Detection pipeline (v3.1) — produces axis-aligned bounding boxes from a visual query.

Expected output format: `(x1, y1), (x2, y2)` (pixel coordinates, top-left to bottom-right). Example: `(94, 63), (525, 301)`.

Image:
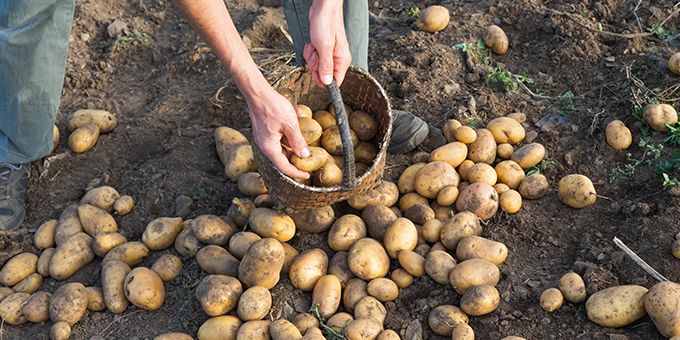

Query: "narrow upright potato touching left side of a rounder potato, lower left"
(102, 260), (131, 314)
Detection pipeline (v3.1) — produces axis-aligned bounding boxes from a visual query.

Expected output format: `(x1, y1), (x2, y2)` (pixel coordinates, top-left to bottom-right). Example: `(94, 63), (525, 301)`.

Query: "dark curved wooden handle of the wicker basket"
(328, 79), (357, 190)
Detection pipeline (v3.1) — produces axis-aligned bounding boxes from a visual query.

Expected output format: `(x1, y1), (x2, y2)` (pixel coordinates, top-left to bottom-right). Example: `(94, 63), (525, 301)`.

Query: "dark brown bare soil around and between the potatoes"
(0, 0), (680, 339)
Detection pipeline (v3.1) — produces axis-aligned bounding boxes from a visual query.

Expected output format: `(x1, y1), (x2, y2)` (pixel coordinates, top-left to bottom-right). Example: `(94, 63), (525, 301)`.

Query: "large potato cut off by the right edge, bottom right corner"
(644, 281), (680, 337)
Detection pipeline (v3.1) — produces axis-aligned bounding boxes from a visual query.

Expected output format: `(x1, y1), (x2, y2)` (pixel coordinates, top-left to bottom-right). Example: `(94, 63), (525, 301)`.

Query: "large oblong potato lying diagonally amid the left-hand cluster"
(49, 232), (94, 283)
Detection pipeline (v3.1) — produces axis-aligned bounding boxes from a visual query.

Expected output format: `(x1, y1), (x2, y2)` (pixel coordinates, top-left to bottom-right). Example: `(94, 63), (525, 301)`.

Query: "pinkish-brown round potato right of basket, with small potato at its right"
(456, 182), (498, 221)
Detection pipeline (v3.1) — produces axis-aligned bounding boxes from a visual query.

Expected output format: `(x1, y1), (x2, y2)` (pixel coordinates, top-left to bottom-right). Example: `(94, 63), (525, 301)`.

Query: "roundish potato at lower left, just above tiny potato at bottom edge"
(49, 282), (87, 326)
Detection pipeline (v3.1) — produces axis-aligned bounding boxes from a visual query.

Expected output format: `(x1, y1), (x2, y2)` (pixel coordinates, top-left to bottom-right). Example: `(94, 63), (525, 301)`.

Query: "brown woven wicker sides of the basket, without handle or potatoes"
(253, 67), (392, 213)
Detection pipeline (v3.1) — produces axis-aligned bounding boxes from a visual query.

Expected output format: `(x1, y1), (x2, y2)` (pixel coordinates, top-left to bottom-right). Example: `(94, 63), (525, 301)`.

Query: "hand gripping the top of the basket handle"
(303, 0), (352, 87)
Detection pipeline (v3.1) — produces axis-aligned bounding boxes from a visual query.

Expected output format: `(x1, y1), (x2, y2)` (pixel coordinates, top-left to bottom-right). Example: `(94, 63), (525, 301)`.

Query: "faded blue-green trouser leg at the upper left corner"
(0, 0), (75, 164)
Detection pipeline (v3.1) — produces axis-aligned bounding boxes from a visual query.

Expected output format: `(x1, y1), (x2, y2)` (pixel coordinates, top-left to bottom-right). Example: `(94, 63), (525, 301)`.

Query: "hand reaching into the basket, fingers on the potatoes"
(248, 87), (309, 179)
